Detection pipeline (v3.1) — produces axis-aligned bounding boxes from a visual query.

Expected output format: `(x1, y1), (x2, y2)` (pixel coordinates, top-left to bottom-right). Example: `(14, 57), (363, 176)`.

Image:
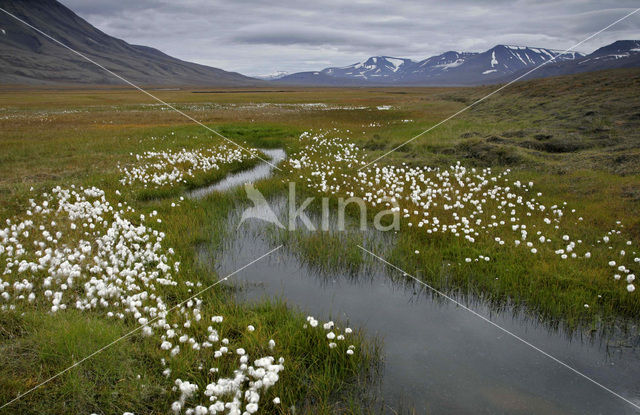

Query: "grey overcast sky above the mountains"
(57, 0), (640, 75)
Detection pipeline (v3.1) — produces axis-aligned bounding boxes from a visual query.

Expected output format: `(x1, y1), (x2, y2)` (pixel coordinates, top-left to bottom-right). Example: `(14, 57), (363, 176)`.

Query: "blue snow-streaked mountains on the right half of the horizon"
(277, 40), (640, 86)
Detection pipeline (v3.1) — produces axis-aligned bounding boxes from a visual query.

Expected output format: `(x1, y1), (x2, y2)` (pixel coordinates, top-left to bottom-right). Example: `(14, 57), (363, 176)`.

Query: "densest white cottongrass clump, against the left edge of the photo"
(0, 187), (180, 316)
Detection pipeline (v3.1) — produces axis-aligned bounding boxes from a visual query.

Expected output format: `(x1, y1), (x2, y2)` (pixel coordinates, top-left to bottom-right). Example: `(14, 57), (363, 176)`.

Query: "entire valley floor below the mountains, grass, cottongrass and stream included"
(0, 69), (640, 414)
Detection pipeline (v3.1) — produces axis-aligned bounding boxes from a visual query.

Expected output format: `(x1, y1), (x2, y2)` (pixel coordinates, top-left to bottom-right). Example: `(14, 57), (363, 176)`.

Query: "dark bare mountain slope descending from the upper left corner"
(0, 0), (260, 86)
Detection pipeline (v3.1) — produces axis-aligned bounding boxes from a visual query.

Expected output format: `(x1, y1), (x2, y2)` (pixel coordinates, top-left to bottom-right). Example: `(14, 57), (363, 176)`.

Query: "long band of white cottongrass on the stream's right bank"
(287, 130), (640, 293)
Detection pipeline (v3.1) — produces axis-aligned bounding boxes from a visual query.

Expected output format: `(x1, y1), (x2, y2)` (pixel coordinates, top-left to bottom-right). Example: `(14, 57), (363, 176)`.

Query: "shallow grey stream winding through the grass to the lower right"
(199, 152), (640, 414)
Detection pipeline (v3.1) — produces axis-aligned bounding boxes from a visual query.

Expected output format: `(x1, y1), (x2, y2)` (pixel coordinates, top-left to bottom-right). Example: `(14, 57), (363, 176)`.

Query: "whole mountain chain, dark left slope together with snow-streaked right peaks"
(0, 0), (640, 86)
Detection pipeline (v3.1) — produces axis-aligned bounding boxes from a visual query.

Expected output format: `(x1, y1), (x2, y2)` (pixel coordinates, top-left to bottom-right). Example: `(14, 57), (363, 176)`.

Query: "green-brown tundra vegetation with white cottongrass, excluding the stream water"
(0, 69), (640, 414)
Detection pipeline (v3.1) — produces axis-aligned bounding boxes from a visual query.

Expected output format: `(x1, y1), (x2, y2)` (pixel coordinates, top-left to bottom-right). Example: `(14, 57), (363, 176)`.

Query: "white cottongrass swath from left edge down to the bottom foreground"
(0, 180), (354, 415)
